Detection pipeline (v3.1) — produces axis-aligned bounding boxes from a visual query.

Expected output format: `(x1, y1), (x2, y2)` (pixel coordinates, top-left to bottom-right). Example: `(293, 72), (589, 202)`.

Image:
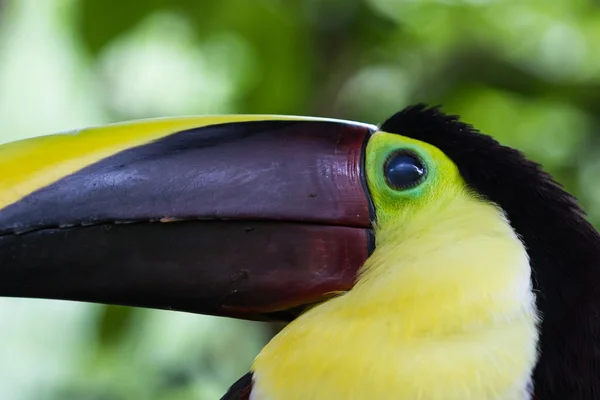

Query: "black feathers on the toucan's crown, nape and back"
(381, 105), (600, 400)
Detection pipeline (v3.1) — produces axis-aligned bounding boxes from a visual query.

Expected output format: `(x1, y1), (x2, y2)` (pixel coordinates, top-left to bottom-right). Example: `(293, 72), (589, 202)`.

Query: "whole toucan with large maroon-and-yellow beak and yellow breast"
(0, 104), (600, 400)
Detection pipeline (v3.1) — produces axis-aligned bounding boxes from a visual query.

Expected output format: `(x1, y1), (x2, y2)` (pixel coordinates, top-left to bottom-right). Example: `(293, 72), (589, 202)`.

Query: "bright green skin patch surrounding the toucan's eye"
(366, 131), (465, 227)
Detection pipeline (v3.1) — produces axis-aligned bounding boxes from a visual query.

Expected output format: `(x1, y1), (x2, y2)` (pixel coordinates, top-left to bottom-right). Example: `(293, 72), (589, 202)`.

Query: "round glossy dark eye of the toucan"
(383, 150), (427, 190)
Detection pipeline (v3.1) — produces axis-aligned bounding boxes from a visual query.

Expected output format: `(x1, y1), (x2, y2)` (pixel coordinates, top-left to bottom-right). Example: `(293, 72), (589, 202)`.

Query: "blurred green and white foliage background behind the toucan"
(0, 0), (600, 400)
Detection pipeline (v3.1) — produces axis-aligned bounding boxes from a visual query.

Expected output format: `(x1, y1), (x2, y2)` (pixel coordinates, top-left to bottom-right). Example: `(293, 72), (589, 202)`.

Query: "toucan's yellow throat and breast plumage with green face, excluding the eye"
(252, 132), (538, 400)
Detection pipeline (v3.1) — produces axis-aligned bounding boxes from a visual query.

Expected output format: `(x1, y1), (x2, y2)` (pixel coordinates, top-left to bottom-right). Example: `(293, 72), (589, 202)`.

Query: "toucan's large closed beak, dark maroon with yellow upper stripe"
(0, 117), (375, 319)
